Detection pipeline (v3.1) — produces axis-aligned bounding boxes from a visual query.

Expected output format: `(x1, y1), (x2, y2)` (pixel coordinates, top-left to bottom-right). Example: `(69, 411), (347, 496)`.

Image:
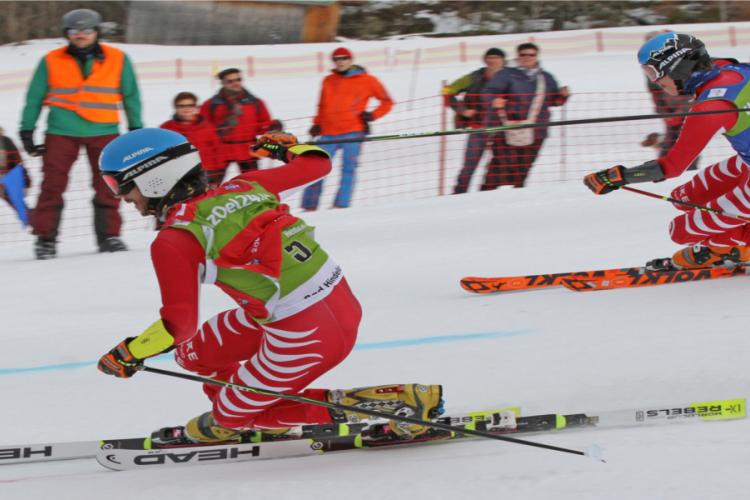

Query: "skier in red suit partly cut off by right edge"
(583, 32), (750, 269)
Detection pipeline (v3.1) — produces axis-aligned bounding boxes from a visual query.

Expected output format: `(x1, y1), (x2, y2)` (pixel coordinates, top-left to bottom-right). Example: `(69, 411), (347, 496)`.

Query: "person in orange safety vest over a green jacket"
(19, 9), (143, 259)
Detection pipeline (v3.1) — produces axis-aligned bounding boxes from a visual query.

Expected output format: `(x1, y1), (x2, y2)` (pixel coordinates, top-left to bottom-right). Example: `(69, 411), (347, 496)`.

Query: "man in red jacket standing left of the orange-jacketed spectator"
(200, 68), (281, 185)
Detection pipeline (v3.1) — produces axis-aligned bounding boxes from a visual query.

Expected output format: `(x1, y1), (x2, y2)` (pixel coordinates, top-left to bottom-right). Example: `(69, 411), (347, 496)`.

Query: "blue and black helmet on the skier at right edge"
(638, 32), (711, 88)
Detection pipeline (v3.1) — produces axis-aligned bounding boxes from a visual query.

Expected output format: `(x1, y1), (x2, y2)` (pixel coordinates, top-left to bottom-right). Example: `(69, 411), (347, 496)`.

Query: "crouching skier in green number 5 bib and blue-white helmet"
(98, 128), (442, 445)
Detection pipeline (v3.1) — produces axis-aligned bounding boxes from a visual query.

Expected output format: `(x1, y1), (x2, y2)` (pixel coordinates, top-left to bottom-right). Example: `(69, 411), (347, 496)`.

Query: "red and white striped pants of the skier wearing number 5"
(175, 279), (362, 429)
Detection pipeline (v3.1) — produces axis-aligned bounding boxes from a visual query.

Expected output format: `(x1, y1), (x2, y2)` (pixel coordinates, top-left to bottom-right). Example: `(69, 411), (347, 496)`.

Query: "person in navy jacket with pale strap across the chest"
(482, 43), (570, 189)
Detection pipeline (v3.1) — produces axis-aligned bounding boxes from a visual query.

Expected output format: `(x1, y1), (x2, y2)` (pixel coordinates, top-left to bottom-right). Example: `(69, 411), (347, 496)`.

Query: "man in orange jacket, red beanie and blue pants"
(302, 47), (393, 210)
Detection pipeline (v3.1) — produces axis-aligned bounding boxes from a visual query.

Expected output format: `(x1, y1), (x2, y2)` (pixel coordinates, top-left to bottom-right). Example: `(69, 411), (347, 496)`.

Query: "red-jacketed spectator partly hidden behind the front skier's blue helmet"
(161, 92), (226, 185)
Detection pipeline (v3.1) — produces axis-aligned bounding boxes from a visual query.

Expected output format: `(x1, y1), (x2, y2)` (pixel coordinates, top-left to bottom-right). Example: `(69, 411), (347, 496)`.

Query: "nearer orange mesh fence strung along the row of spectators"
(0, 91), (733, 245)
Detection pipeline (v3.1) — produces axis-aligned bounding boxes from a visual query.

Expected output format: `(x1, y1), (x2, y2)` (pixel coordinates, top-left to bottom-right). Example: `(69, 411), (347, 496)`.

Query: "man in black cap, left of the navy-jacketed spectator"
(443, 47), (505, 194)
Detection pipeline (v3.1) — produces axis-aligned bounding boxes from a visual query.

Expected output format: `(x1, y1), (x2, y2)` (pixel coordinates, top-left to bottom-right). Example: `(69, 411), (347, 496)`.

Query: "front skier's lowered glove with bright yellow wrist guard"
(97, 320), (174, 378)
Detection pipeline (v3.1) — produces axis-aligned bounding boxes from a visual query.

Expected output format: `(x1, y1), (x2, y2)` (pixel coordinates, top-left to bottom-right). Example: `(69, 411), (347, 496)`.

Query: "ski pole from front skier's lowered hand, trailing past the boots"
(137, 365), (604, 462)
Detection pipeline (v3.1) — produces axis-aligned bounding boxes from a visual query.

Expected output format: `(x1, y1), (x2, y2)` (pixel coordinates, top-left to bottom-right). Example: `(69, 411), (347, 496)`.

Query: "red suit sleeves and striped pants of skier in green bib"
(151, 155), (362, 428)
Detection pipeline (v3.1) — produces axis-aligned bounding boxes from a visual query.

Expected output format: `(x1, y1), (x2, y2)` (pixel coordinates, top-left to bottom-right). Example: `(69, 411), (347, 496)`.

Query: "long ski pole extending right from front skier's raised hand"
(312, 108), (748, 146)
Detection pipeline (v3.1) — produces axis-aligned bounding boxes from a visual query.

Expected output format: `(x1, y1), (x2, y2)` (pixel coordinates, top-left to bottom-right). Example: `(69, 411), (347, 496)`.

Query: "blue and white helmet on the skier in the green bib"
(99, 128), (206, 200)
